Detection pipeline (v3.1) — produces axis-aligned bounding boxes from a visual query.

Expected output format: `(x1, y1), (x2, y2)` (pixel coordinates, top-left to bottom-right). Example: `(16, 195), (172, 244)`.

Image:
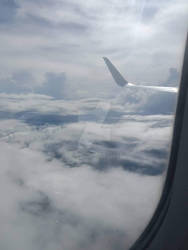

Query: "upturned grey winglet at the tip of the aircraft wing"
(103, 57), (128, 87)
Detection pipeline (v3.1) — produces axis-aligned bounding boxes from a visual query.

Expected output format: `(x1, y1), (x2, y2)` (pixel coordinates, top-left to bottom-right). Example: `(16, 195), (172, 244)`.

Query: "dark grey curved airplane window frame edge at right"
(130, 35), (188, 250)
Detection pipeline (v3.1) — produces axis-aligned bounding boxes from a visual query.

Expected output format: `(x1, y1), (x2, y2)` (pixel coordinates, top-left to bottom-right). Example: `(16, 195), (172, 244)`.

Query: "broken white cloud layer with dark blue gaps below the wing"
(0, 92), (172, 175)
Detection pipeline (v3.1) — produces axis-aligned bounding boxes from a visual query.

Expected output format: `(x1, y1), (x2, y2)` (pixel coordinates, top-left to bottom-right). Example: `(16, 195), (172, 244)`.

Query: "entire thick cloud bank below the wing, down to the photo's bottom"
(0, 94), (173, 250)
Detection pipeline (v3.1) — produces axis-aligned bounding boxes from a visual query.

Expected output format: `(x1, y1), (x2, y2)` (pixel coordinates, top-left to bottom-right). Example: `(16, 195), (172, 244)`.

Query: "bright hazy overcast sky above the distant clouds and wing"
(0, 0), (187, 97)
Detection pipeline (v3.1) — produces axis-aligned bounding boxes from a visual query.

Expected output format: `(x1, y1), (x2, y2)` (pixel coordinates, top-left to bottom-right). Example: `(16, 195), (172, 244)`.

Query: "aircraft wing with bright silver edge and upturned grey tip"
(103, 57), (178, 93)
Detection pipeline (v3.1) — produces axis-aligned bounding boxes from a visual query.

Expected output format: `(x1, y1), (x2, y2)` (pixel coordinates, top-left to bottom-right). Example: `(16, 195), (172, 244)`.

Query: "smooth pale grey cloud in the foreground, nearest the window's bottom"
(0, 143), (162, 250)
